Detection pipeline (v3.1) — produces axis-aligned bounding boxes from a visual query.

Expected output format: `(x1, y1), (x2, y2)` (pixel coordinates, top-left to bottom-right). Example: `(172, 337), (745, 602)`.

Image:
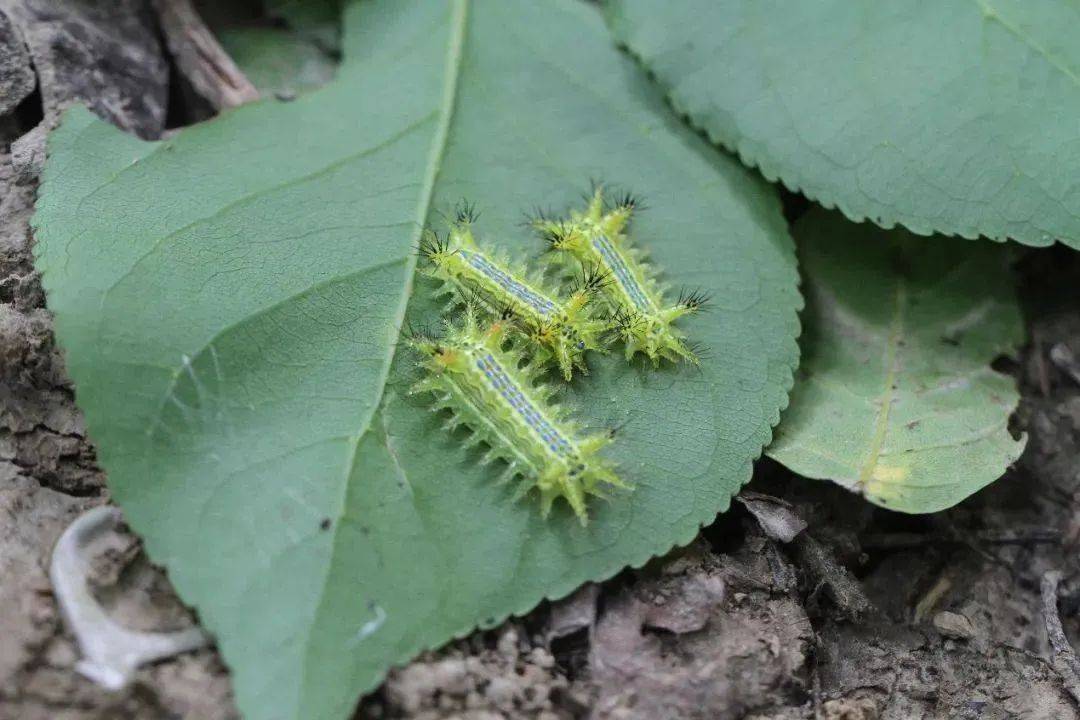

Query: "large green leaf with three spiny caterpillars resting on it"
(36, 0), (801, 720)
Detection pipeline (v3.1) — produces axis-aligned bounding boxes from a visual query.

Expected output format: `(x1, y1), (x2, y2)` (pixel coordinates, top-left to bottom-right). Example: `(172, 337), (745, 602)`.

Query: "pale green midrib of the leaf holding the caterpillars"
(294, 0), (469, 717)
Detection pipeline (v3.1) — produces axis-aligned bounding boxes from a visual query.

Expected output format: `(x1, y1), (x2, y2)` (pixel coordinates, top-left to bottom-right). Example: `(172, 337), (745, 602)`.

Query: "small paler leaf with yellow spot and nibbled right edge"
(768, 209), (1024, 513)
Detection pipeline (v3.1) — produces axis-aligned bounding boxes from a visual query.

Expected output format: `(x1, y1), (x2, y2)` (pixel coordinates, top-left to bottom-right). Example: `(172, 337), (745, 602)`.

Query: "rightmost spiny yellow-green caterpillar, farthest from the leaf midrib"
(534, 187), (708, 366)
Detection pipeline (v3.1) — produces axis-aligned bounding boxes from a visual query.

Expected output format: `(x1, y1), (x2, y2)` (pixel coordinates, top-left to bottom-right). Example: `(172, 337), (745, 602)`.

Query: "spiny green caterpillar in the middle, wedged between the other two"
(420, 203), (608, 381)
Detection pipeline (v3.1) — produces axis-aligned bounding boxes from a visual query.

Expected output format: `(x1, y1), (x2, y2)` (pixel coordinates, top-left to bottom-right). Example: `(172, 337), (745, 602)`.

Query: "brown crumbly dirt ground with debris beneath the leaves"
(0, 0), (1080, 720)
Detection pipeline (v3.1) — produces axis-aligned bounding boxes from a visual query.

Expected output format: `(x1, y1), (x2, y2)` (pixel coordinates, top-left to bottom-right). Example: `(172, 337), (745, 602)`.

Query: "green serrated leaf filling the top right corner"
(611, 0), (1080, 248)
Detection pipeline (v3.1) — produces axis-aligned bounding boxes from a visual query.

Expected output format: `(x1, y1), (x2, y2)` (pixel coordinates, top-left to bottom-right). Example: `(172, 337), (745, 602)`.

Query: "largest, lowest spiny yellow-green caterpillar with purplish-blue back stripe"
(409, 304), (625, 525)
